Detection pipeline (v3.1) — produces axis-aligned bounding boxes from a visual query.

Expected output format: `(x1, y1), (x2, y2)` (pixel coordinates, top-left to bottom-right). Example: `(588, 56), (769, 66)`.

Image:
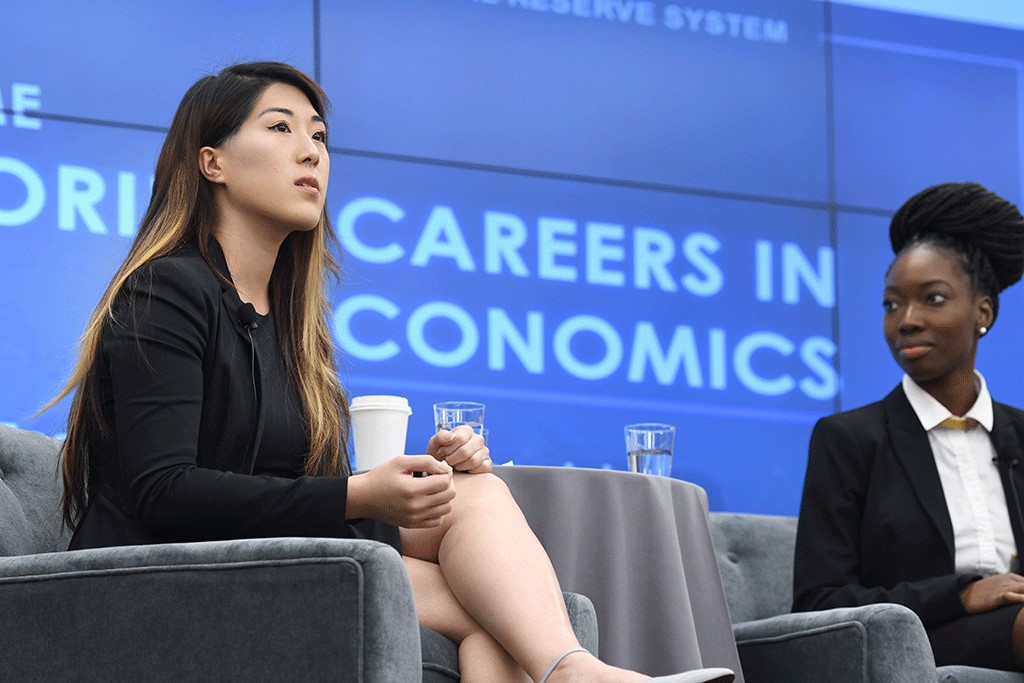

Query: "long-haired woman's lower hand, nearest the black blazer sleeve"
(345, 456), (455, 528)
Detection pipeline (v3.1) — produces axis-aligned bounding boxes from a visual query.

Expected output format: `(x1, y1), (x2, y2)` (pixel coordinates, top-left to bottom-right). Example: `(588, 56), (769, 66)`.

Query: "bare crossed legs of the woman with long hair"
(400, 473), (644, 683)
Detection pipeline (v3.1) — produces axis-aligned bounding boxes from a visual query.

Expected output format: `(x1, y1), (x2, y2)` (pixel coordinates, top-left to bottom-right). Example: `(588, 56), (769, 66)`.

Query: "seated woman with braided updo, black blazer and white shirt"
(794, 183), (1024, 671)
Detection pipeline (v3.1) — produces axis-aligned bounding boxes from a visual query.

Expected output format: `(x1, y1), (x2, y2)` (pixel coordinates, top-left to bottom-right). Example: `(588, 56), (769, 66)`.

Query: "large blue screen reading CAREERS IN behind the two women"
(0, 0), (1024, 514)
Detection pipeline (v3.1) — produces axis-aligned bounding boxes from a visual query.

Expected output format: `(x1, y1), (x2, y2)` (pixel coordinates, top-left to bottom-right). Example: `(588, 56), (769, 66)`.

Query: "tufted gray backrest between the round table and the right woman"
(711, 512), (797, 624)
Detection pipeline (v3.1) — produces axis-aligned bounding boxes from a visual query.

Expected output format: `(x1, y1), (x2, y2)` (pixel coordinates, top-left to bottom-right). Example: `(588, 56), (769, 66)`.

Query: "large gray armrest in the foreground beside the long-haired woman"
(0, 539), (421, 683)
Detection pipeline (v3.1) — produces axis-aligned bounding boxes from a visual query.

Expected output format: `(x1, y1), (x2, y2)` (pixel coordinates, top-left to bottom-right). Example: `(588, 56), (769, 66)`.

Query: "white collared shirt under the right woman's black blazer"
(903, 371), (1017, 575)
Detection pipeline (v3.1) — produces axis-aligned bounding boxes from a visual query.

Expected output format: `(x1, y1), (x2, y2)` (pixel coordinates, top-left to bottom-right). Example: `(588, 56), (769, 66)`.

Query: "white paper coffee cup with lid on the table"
(348, 395), (413, 470)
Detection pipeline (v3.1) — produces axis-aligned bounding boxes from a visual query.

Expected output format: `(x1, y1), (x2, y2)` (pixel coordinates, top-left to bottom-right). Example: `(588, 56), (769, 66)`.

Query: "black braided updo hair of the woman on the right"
(889, 182), (1024, 323)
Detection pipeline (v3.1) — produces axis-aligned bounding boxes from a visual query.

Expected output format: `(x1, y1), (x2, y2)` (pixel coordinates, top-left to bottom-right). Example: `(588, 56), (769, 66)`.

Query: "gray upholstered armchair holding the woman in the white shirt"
(711, 512), (1024, 683)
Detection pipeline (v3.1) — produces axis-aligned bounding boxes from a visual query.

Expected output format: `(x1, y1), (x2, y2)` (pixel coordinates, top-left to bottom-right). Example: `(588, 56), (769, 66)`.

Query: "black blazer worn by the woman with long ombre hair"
(71, 240), (358, 549)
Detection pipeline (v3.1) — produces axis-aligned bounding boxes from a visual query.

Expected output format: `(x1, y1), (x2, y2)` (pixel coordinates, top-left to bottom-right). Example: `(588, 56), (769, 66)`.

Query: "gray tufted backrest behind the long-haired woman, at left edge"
(0, 425), (71, 556)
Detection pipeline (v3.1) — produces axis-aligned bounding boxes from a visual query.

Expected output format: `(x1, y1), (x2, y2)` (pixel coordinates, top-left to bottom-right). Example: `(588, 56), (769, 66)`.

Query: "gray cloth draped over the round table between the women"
(495, 466), (743, 683)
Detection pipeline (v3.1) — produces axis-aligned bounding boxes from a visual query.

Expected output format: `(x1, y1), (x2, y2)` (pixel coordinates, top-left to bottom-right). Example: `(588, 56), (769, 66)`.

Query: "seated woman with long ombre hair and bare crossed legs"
(51, 62), (733, 683)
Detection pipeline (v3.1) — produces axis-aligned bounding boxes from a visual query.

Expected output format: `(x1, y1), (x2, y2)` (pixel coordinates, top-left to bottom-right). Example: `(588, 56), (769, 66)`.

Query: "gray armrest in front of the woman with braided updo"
(733, 604), (936, 683)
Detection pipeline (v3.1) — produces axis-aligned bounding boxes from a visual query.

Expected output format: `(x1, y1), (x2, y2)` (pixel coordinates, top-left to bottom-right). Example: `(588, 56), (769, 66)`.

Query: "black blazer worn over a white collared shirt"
(794, 386), (1024, 627)
